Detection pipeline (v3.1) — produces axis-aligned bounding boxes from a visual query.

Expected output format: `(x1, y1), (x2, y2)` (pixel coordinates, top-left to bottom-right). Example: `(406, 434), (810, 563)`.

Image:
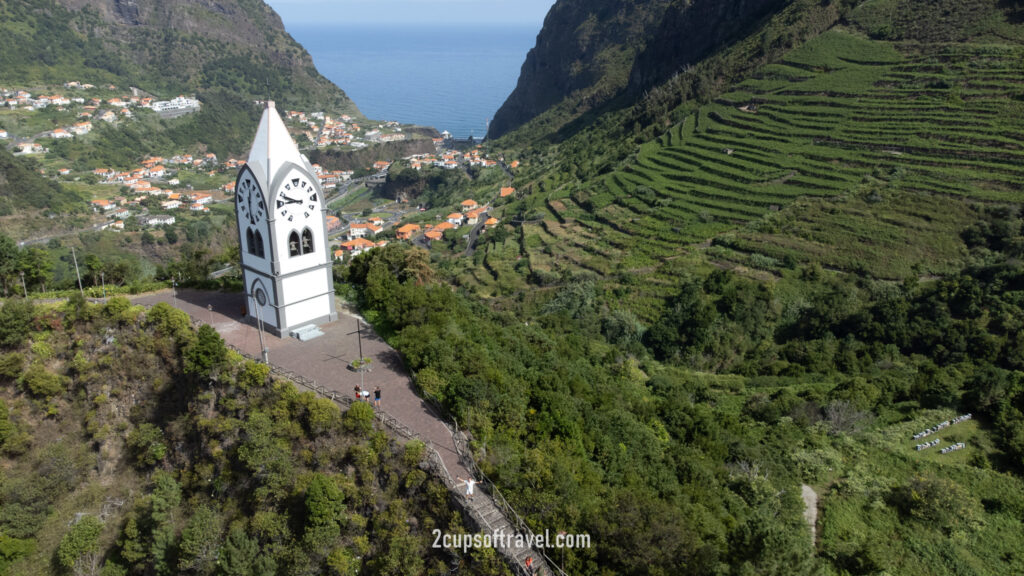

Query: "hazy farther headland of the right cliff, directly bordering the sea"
(487, 0), (670, 138)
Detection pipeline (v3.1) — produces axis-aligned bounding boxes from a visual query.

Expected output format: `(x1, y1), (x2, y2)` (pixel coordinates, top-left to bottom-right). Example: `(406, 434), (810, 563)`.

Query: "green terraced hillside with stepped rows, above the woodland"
(478, 28), (1024, 309)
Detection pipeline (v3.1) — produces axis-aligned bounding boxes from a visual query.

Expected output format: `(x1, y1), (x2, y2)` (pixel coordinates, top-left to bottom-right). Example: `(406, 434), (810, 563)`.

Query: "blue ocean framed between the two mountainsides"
(289, 25), (539, 138)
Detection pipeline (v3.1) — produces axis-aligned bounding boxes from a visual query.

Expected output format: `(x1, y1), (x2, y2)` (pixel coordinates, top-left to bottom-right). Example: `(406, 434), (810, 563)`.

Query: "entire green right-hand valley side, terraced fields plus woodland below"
(340, 0), (1024, 575)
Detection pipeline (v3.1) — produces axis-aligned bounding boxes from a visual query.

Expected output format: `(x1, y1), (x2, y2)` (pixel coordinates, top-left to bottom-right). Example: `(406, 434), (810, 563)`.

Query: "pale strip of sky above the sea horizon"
(260, 0), (554, 25)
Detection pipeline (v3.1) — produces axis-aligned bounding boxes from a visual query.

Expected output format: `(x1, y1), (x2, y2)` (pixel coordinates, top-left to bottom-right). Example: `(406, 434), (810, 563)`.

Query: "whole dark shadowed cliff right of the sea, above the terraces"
(487, 0), (791, 137)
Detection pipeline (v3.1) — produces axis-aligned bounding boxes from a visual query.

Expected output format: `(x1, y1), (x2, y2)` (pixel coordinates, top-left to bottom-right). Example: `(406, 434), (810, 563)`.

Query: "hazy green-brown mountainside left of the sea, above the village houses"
(0, 0), (358, 113)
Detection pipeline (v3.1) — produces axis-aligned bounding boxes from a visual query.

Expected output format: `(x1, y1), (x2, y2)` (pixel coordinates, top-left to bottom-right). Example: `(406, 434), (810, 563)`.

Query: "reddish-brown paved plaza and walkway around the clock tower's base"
(133, 290), (470, 478)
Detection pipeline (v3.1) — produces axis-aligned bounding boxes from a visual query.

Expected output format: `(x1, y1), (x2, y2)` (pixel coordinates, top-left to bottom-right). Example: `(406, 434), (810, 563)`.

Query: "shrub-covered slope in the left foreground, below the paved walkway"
(0, 298), (508, 576)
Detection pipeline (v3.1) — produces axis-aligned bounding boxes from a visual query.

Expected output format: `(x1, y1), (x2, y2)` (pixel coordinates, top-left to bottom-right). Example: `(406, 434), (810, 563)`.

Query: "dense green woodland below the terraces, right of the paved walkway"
(345, 200), (1024, 574)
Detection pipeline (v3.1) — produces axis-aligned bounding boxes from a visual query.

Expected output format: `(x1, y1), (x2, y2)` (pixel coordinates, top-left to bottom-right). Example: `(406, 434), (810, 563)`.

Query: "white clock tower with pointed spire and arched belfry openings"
(234, 101), (338, 336)
